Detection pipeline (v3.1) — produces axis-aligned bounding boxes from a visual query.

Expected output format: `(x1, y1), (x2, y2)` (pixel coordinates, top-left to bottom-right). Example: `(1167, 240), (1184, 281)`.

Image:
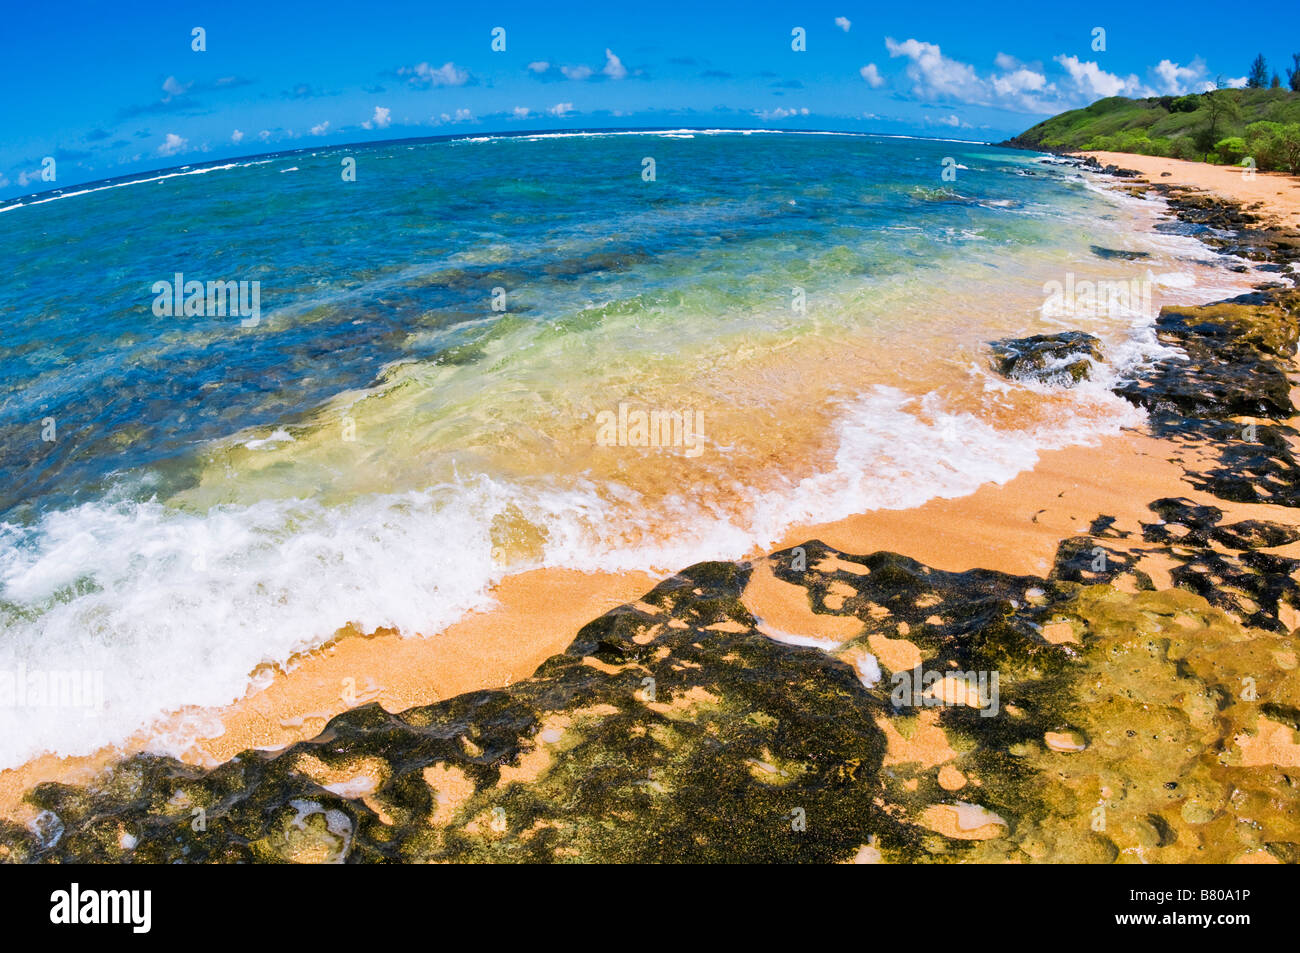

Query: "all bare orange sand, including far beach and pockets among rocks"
(10, 153), (1300, 853)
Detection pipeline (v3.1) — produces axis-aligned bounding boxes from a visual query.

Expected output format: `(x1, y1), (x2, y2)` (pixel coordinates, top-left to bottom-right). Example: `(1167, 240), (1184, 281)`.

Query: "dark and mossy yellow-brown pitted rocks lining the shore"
(0, 163), (1300, 863)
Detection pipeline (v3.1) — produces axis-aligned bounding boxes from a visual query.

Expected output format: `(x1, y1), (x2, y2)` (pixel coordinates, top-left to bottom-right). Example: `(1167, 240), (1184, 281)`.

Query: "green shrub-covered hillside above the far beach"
(1006, 88), (1300, 173)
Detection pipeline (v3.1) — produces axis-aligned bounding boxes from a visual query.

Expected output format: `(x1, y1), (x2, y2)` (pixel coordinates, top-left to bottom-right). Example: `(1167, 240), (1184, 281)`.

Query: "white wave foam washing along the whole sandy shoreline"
(0, 139), (1263, 768)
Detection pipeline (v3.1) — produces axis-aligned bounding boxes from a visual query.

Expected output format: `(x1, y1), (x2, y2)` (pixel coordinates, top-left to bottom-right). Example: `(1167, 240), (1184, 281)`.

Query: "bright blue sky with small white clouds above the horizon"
(0, 0), (1300, 196)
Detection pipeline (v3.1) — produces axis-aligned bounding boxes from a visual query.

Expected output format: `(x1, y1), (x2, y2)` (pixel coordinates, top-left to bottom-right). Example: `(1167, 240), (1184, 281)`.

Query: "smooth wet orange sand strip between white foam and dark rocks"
(0, 423), (1248, 818)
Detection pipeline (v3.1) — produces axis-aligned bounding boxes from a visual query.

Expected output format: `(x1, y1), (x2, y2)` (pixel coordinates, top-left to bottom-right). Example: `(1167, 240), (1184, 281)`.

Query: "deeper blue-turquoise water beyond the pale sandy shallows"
(0, 135), (1107, 517)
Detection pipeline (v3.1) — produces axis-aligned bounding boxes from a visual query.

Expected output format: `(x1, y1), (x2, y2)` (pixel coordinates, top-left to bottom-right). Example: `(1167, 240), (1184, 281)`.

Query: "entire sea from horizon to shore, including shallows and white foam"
(0, 131), (1258, 767)
